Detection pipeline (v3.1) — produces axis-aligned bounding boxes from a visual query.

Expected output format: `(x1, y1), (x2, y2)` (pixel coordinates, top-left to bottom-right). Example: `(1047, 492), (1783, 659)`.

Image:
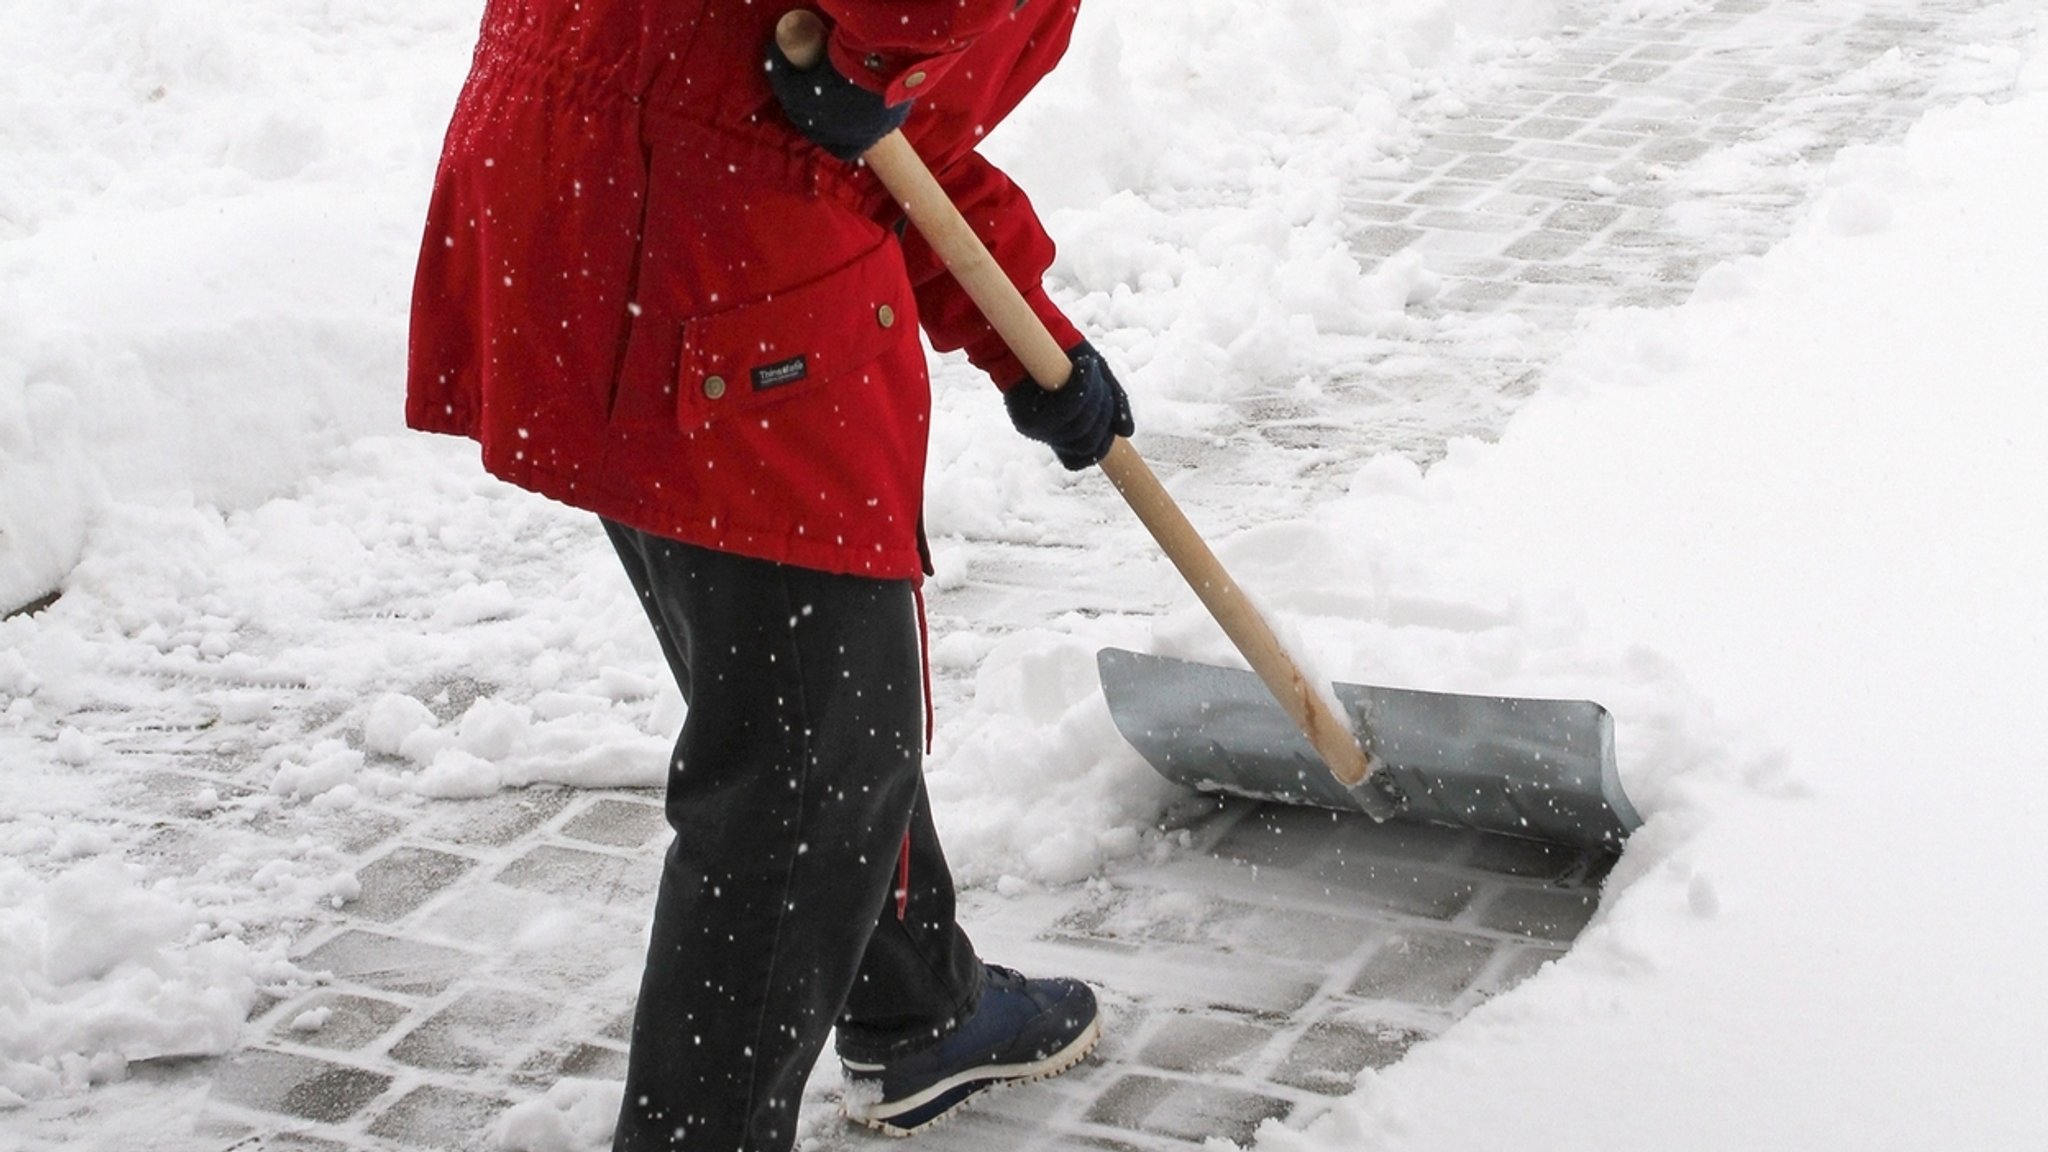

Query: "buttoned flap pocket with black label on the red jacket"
(676, 240), (918, 430)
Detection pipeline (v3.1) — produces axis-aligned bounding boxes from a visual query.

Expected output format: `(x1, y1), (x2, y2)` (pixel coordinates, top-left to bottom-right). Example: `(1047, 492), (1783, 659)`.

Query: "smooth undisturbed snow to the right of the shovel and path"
(1268, 59), (2048, 1150)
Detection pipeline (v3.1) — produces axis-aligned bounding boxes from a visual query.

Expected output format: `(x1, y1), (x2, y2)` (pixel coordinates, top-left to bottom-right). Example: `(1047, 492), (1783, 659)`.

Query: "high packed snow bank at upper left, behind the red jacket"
(0, 0), (477, 611)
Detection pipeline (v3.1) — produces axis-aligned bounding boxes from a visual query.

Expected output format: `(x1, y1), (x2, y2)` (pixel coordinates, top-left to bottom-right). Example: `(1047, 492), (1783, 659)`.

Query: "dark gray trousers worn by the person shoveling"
(604, 521), (981, 1152)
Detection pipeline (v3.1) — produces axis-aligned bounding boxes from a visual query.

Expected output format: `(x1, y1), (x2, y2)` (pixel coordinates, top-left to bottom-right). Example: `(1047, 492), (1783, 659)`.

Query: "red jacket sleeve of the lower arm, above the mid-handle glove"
(903, 152), (1081, 389)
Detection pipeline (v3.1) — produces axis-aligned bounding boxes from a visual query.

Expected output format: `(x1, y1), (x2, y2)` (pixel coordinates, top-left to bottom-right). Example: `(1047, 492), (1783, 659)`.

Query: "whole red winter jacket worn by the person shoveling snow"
(406, 0), (1079, 578)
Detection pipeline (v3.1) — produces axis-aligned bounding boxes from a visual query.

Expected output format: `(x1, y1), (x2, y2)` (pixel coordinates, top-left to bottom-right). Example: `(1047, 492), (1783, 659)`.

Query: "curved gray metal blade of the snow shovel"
(1096, 648), (1642, 851)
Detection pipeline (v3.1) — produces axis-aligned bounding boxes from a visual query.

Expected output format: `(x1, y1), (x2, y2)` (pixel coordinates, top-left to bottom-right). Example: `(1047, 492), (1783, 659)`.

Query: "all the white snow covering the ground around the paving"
(0, 0), (2048, 1152)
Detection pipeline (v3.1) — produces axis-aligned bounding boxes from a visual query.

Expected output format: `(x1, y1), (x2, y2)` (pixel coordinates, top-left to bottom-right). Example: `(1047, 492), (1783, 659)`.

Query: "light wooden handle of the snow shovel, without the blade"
(776, 10), (1384, 799)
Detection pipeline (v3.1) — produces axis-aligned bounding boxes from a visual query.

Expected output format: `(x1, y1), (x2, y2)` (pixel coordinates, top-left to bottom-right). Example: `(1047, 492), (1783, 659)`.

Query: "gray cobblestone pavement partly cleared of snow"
(6, 0), (2031, 1152)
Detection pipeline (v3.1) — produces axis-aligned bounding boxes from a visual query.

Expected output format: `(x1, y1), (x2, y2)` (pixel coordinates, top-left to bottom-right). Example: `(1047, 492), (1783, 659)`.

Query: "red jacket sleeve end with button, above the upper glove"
(817, 0), (1022, 105)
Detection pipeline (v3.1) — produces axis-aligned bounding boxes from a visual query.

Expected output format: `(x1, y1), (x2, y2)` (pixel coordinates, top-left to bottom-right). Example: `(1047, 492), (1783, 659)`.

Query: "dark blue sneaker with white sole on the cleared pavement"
(842, 963), (1102, 1136)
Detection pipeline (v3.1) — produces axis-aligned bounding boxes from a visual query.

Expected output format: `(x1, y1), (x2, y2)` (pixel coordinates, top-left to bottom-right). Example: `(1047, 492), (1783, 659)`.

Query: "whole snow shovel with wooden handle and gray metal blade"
(776, 8), (1634, 842)
